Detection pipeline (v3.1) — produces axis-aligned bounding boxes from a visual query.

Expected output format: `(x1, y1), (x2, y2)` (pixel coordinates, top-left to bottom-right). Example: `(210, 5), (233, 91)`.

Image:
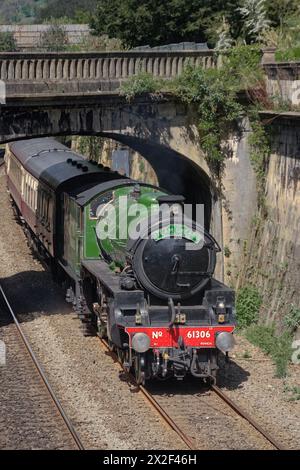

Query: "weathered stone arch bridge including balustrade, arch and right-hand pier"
(0, 50), (255, 279)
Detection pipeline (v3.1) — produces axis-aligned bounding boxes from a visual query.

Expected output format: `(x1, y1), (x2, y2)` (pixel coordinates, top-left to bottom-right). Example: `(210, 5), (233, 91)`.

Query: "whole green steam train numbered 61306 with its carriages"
(5, 138), (235, 383)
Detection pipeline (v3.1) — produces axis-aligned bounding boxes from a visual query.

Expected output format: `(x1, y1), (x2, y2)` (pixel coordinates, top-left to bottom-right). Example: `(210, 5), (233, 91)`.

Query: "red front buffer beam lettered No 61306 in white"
(125, 326), (234, 348)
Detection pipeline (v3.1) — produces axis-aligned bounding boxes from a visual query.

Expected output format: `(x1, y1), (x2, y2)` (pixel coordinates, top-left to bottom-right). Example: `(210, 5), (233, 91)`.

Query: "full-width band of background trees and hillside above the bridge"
(0, 0), (300, 60)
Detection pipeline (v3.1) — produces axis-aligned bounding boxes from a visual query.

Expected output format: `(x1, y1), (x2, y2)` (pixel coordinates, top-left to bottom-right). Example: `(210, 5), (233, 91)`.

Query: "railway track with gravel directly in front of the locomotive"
(100, 339), (284, 450)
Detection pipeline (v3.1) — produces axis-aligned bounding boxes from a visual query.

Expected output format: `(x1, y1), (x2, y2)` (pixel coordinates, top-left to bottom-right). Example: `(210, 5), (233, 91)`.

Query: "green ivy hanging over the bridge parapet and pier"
(120, 45), (267, 177)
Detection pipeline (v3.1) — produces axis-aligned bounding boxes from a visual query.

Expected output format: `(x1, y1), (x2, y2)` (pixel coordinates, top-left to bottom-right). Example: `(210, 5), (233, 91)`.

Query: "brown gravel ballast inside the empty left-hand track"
(0, 305), (77, 450)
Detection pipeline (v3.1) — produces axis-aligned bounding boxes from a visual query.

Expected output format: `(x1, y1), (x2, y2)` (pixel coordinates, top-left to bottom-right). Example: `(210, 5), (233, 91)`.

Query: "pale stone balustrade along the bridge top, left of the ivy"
(0, 50), (217, 96)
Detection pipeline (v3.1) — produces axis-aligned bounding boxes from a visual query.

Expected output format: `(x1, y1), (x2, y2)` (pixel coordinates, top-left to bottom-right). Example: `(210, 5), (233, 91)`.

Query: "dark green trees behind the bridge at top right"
(91, 0), (300, 50)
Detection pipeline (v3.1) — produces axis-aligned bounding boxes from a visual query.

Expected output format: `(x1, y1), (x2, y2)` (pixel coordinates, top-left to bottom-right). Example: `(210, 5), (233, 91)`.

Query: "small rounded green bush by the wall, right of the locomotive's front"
(236, 286), (262, 328)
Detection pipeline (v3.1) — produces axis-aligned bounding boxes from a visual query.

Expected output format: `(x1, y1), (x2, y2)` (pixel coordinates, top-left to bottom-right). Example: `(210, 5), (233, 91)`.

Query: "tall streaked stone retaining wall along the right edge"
(240, 115), (300, 325)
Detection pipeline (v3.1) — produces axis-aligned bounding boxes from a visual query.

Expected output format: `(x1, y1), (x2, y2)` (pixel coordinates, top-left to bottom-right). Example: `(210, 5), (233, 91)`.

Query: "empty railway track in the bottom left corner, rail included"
(0, 284), (84, 450)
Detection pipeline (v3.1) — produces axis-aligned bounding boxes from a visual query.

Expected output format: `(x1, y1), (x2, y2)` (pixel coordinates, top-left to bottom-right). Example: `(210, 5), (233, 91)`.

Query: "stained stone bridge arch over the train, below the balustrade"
(0, 93), (222, 233)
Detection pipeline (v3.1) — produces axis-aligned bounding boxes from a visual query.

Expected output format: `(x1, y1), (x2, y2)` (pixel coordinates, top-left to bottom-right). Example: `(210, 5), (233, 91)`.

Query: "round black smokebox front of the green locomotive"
(132, 217), (219, 301)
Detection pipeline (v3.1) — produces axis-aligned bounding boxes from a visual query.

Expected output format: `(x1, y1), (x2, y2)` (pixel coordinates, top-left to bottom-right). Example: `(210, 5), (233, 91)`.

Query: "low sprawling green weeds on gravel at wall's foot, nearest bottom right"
(245, 325), (292, 377)
